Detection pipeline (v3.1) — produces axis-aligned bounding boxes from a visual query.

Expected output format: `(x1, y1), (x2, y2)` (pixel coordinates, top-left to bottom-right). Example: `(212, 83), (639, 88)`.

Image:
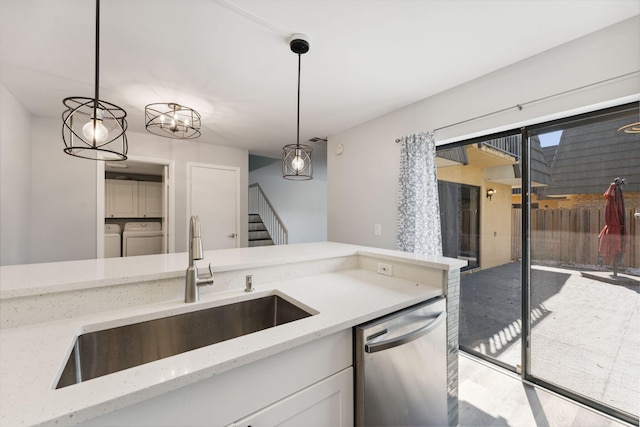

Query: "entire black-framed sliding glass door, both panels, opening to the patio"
(444, 103), (640, 424)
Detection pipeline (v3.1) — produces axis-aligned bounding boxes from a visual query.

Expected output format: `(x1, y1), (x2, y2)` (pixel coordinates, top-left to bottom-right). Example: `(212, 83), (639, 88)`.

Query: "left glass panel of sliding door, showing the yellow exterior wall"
(437, 134), (522, 370)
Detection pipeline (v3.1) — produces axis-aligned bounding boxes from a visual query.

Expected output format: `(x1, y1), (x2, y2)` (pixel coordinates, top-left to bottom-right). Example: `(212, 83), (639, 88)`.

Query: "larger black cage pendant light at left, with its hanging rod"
(62, 0), (128, 160)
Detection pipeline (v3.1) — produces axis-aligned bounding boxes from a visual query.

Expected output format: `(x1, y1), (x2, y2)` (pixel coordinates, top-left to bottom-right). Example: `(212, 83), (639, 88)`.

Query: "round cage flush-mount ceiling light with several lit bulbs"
(144, 102), (200, 139)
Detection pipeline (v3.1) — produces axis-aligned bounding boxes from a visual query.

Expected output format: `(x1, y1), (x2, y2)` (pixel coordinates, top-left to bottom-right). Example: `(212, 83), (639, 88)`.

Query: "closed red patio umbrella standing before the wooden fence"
(598, 178), (627, 273)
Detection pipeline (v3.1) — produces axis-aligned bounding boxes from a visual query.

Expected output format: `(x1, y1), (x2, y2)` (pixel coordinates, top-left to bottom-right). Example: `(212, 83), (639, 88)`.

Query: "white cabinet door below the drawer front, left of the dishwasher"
(233, 368), (353, 427)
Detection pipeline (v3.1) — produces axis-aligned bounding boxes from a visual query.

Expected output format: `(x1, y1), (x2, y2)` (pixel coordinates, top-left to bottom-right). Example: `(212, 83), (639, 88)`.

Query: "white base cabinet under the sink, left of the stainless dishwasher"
(82, 329), (353, 427)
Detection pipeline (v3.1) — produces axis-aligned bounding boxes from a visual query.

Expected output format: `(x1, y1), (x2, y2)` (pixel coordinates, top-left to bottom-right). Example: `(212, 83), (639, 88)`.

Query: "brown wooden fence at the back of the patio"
(511, 208), (640, 268)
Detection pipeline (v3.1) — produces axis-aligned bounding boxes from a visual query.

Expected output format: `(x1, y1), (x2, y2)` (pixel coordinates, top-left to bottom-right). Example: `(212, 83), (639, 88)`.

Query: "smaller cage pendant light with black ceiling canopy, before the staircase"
(282, 34), (313, 181)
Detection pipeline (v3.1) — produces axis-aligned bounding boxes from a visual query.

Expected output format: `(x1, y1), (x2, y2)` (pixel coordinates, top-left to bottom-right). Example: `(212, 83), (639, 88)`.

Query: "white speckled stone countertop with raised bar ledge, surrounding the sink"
(0, 242), (464, 426)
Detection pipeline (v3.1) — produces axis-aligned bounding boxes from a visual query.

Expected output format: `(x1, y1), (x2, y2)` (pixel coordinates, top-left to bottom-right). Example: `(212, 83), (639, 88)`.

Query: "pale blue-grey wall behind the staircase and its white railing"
(249, 144), (327, 243)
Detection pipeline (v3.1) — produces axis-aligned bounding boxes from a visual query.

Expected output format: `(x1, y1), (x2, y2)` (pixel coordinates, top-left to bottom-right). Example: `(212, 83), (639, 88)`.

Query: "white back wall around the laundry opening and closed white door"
(0, 113), (248, 263)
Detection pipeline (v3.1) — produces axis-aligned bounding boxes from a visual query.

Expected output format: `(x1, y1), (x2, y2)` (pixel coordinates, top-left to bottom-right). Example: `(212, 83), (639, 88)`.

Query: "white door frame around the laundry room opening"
(96, 156), (176, 259)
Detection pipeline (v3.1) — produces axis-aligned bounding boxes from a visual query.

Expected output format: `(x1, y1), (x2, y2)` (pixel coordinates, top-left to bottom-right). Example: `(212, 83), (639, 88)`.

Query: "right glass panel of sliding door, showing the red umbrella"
(528, 109), (640, 423)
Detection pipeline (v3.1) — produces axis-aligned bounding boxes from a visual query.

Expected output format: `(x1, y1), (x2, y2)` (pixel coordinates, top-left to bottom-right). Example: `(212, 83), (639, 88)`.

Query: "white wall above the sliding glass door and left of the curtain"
(327, 16), (640, 249)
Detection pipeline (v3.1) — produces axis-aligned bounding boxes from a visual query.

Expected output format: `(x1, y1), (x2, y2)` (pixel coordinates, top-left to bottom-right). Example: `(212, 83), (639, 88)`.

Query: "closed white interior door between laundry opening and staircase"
(188, 164), (240, 250)
